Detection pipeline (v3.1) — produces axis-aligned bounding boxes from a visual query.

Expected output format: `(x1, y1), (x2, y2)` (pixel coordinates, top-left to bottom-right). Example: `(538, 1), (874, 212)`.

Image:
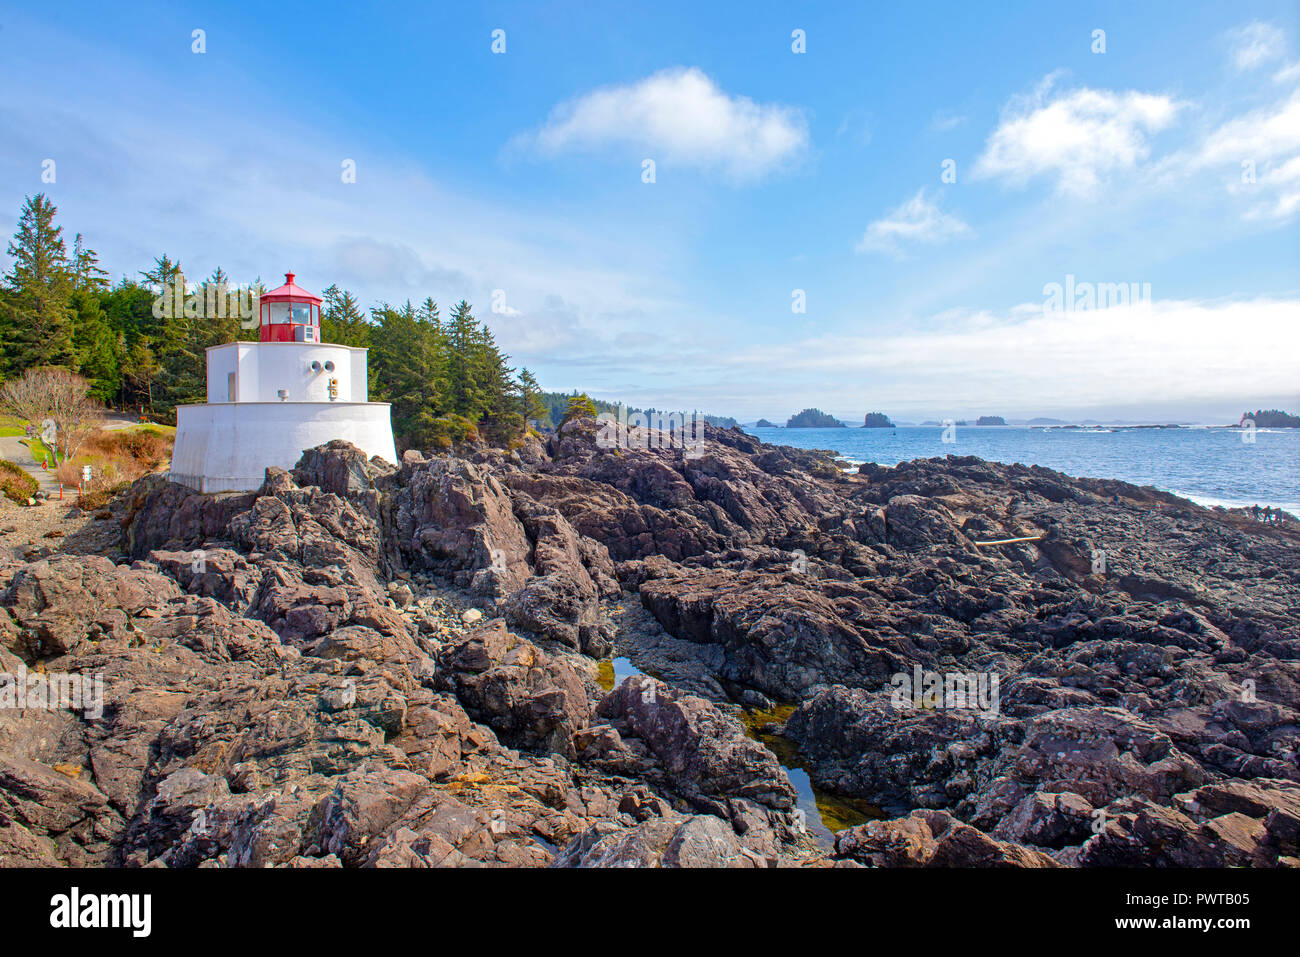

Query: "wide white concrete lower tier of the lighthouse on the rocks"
(170, 402), (398, 493)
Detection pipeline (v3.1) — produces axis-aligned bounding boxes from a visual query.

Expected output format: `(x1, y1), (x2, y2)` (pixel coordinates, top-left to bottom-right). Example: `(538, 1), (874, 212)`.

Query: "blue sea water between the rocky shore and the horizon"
(746, 425), (1300, 515)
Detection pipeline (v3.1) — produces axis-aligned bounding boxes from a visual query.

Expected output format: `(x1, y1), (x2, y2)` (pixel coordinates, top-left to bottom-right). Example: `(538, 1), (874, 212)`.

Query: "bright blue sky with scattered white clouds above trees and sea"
(0, 1), (1300, 421)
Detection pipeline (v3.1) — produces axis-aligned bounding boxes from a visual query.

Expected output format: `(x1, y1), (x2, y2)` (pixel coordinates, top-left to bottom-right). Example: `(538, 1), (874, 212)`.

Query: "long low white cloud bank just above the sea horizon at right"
(723, 295), (1300, 415)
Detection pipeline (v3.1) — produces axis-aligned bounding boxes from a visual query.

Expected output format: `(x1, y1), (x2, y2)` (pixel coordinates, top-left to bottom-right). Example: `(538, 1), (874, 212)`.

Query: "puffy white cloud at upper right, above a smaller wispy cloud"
(975, 75), (1182, 192)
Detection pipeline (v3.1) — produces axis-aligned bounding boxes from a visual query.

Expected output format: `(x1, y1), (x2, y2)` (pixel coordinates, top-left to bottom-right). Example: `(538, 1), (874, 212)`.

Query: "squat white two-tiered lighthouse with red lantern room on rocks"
(170, 273), (397, 493)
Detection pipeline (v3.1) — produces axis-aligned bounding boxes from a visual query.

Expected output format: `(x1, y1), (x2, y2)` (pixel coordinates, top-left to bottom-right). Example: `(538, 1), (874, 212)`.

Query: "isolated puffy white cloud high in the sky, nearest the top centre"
(512, 68), (809, 181)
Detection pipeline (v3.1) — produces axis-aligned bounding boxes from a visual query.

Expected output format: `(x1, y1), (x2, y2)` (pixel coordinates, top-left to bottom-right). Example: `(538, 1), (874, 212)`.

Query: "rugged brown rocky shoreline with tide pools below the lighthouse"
(0, 420), (1300, 867)
